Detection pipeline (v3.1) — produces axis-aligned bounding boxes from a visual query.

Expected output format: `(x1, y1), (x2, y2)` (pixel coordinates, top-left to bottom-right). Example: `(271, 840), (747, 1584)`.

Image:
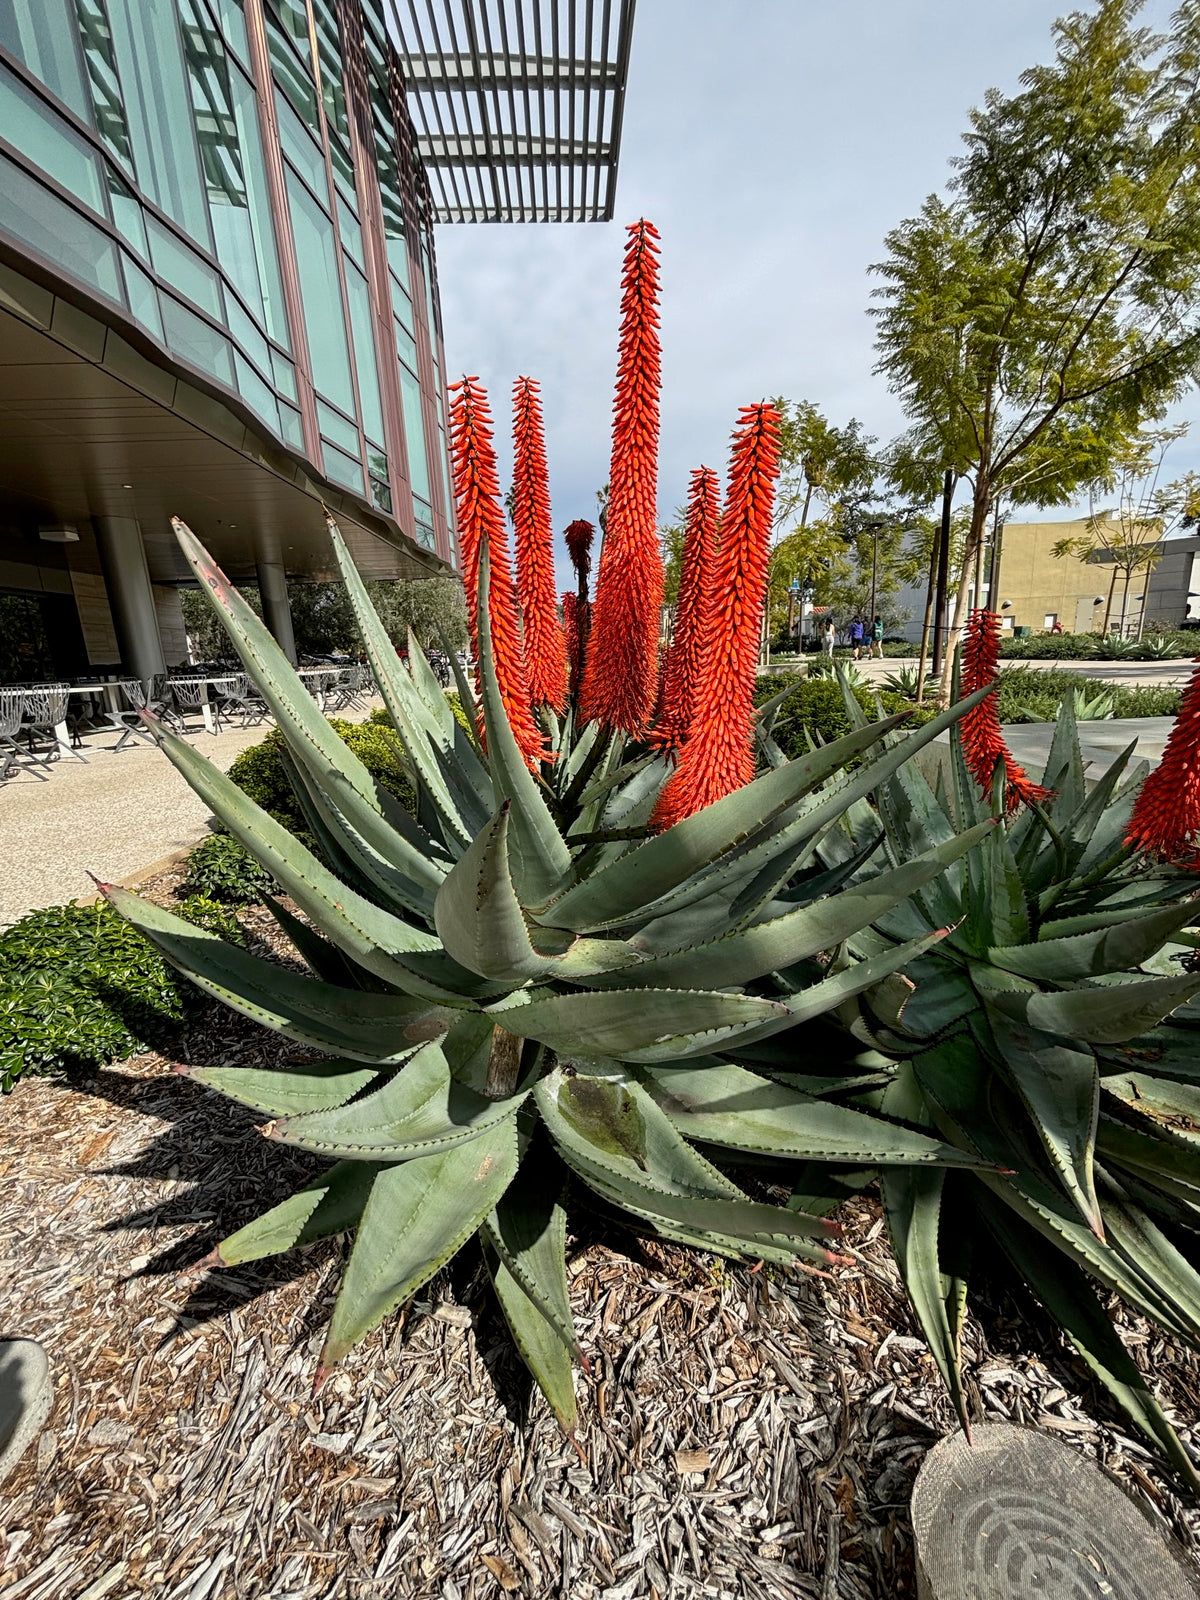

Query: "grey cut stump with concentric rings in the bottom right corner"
(912, 1422), (1200, 1600)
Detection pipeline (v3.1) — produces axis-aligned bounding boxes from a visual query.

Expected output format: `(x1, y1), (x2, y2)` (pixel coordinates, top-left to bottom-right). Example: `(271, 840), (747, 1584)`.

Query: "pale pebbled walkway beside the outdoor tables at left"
(0, 701), (381, 926)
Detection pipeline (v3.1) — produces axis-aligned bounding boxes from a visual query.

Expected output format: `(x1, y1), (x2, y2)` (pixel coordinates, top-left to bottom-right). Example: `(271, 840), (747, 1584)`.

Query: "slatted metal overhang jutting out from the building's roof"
(389, 0), (637, 222)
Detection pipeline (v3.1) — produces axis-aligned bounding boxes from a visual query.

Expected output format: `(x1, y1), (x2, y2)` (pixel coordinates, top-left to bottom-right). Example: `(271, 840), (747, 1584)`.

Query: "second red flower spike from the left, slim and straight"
(512, 378), (566, 712)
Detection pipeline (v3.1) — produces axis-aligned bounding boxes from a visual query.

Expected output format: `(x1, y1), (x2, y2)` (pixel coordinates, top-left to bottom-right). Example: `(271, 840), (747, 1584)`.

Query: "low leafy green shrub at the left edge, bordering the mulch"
(0, 902), (192, 1093)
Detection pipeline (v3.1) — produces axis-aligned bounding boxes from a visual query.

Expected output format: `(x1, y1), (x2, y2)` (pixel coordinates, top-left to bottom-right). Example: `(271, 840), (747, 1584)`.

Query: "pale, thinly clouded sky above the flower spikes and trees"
(437, 0), (1200, 582)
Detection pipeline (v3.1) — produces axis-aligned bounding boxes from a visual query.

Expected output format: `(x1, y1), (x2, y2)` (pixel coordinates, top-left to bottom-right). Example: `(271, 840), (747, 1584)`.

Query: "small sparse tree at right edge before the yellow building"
(1054, 422), (1200, 638)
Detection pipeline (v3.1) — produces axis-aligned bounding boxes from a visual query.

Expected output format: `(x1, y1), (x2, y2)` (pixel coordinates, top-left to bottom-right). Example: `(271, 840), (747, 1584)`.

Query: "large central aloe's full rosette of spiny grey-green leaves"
(106, 525), (1011, 1427)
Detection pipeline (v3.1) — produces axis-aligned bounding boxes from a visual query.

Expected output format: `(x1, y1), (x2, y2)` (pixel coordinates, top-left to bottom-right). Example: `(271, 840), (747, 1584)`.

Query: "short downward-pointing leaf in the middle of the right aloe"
(992, 1014), (1104, 1238)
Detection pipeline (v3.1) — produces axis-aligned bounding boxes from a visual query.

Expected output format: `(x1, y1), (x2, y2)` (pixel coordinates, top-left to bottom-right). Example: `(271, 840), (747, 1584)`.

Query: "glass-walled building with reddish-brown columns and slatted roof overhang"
(0, 0), (632, 678)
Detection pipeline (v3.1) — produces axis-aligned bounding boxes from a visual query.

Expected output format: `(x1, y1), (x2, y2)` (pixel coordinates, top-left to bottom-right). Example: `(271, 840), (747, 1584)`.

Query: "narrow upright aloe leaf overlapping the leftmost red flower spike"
(478, 542), (571, 906)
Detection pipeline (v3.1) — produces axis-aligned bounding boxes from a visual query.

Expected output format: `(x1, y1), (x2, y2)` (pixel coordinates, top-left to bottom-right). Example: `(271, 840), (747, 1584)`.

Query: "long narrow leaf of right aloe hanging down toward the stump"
(880, 1067), (971, 1438)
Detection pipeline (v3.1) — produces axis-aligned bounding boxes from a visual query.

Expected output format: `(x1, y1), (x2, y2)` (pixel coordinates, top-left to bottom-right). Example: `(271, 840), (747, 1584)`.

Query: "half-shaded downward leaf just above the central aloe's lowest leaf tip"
(482, 1150), (579, 1356)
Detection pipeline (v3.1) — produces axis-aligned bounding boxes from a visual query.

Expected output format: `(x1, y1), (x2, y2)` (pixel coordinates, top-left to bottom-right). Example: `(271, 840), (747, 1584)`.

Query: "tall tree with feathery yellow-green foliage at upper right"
(874, 0), (1200, 688)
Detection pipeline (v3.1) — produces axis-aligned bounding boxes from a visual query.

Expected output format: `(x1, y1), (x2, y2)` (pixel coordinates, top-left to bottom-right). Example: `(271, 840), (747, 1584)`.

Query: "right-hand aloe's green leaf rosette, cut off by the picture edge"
(790, 678), (1200, 1486)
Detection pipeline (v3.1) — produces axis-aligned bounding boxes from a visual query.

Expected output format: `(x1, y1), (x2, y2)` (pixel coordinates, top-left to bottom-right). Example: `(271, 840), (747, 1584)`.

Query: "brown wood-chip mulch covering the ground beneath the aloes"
(0, 878), (1200, 1600)
